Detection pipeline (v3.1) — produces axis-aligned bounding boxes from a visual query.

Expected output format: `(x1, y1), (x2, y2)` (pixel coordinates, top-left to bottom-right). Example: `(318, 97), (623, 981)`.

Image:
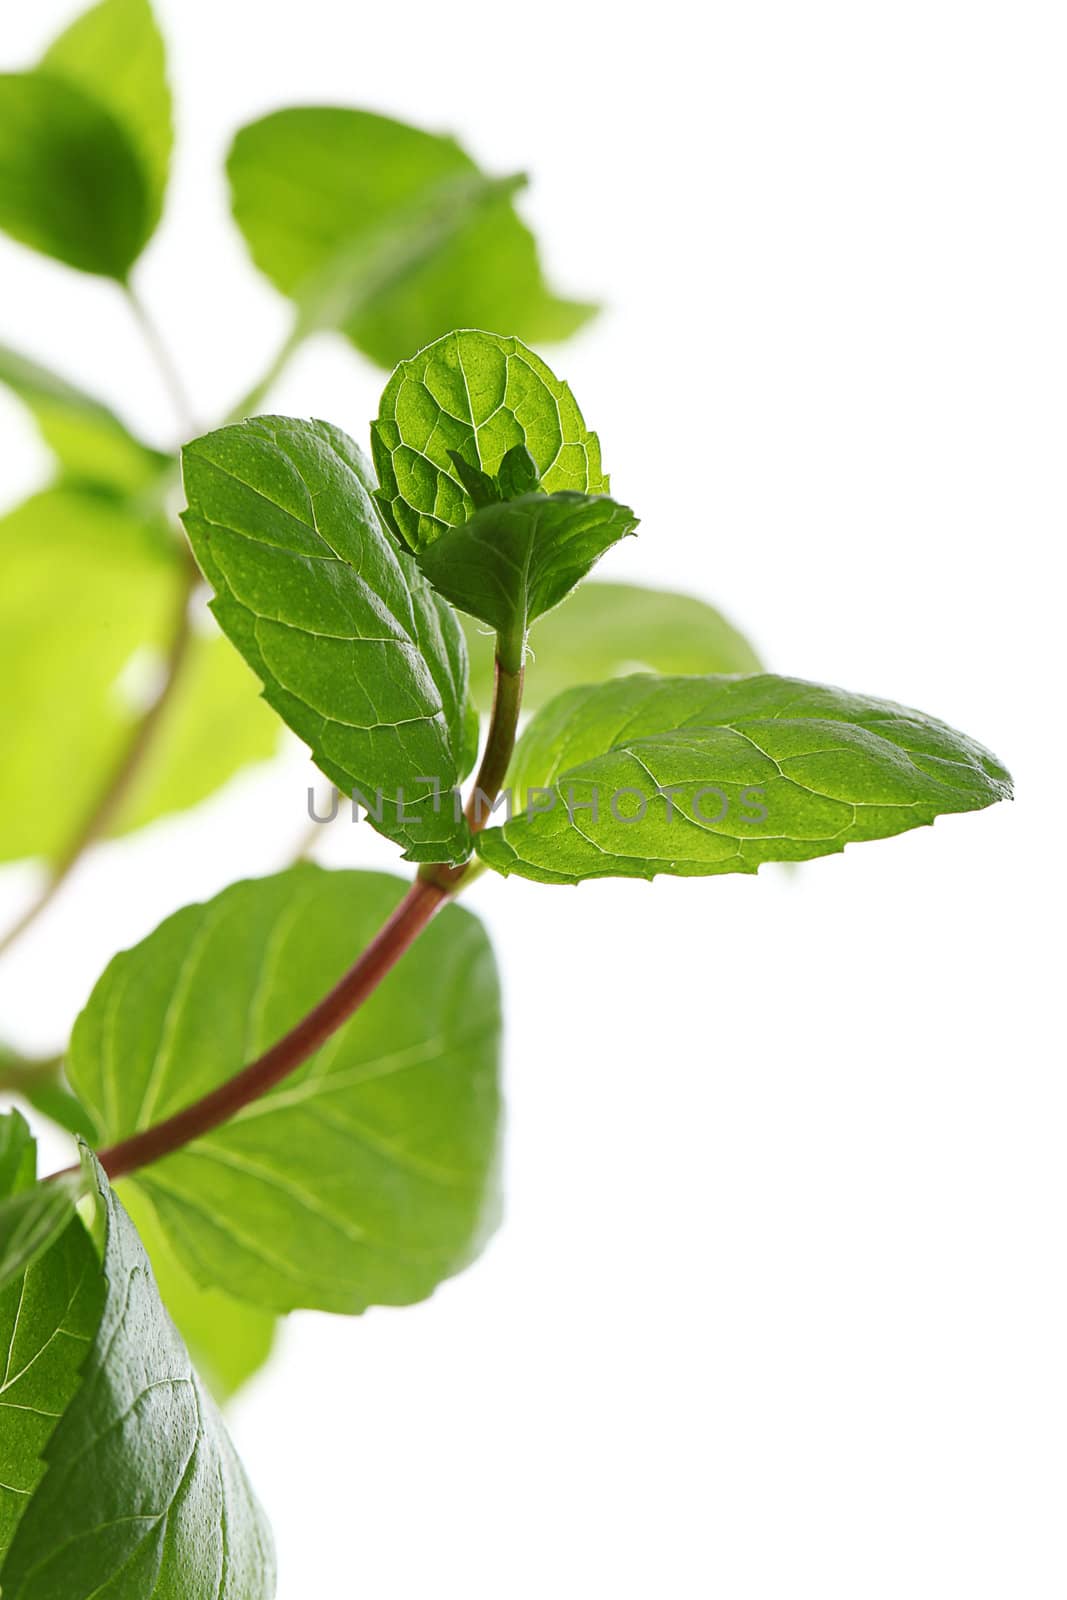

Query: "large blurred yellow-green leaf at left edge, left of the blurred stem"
(0, 488), (184, 861)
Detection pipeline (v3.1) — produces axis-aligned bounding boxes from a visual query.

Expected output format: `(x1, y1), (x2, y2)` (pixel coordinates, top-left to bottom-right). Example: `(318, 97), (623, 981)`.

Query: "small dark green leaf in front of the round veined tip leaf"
(419, 490), (637, 672)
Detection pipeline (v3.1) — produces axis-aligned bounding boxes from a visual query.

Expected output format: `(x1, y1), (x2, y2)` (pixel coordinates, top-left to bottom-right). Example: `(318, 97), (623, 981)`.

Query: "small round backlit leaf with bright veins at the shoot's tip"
(371, 330), (608, 552)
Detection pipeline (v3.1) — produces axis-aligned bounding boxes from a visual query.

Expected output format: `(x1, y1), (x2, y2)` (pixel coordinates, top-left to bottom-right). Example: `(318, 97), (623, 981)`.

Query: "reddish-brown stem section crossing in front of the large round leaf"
(87, 878), (448, 1178)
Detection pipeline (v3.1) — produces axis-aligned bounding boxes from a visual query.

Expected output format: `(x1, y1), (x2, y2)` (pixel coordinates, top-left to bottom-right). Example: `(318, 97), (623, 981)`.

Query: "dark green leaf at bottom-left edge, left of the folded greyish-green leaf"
(0, 1158), (104, 1568)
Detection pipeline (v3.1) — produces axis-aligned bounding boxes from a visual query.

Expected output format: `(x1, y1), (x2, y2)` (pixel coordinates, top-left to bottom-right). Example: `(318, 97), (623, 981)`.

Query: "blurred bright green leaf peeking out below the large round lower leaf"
(118, 1182), (277, 1403)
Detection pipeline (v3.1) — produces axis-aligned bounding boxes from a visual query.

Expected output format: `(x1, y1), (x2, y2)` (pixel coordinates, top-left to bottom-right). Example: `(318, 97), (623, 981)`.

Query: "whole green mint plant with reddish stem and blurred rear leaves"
(0, 0), (1009, 1600)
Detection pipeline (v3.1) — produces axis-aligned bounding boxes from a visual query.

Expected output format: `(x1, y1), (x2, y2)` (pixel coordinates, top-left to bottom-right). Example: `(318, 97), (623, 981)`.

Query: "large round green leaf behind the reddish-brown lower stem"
(69, 866), (499, 1318)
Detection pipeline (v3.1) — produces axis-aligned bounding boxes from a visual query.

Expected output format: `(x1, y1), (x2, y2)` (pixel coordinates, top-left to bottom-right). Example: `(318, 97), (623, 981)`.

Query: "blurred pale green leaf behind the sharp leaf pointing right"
(464, 581), (761, 710)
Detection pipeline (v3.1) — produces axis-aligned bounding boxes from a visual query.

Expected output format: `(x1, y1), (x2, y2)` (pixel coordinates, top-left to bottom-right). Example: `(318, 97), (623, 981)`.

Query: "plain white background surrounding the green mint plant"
(0, 0), (1067, 1600)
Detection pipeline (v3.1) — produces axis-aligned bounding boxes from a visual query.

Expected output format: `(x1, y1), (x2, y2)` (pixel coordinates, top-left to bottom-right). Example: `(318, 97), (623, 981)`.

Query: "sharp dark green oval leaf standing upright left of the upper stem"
(182, 418), (470, 862)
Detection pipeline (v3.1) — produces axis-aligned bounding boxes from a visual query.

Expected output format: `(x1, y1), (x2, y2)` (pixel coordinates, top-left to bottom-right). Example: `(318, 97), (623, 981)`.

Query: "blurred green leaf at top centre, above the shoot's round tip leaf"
(227, 106), (593, 366)
